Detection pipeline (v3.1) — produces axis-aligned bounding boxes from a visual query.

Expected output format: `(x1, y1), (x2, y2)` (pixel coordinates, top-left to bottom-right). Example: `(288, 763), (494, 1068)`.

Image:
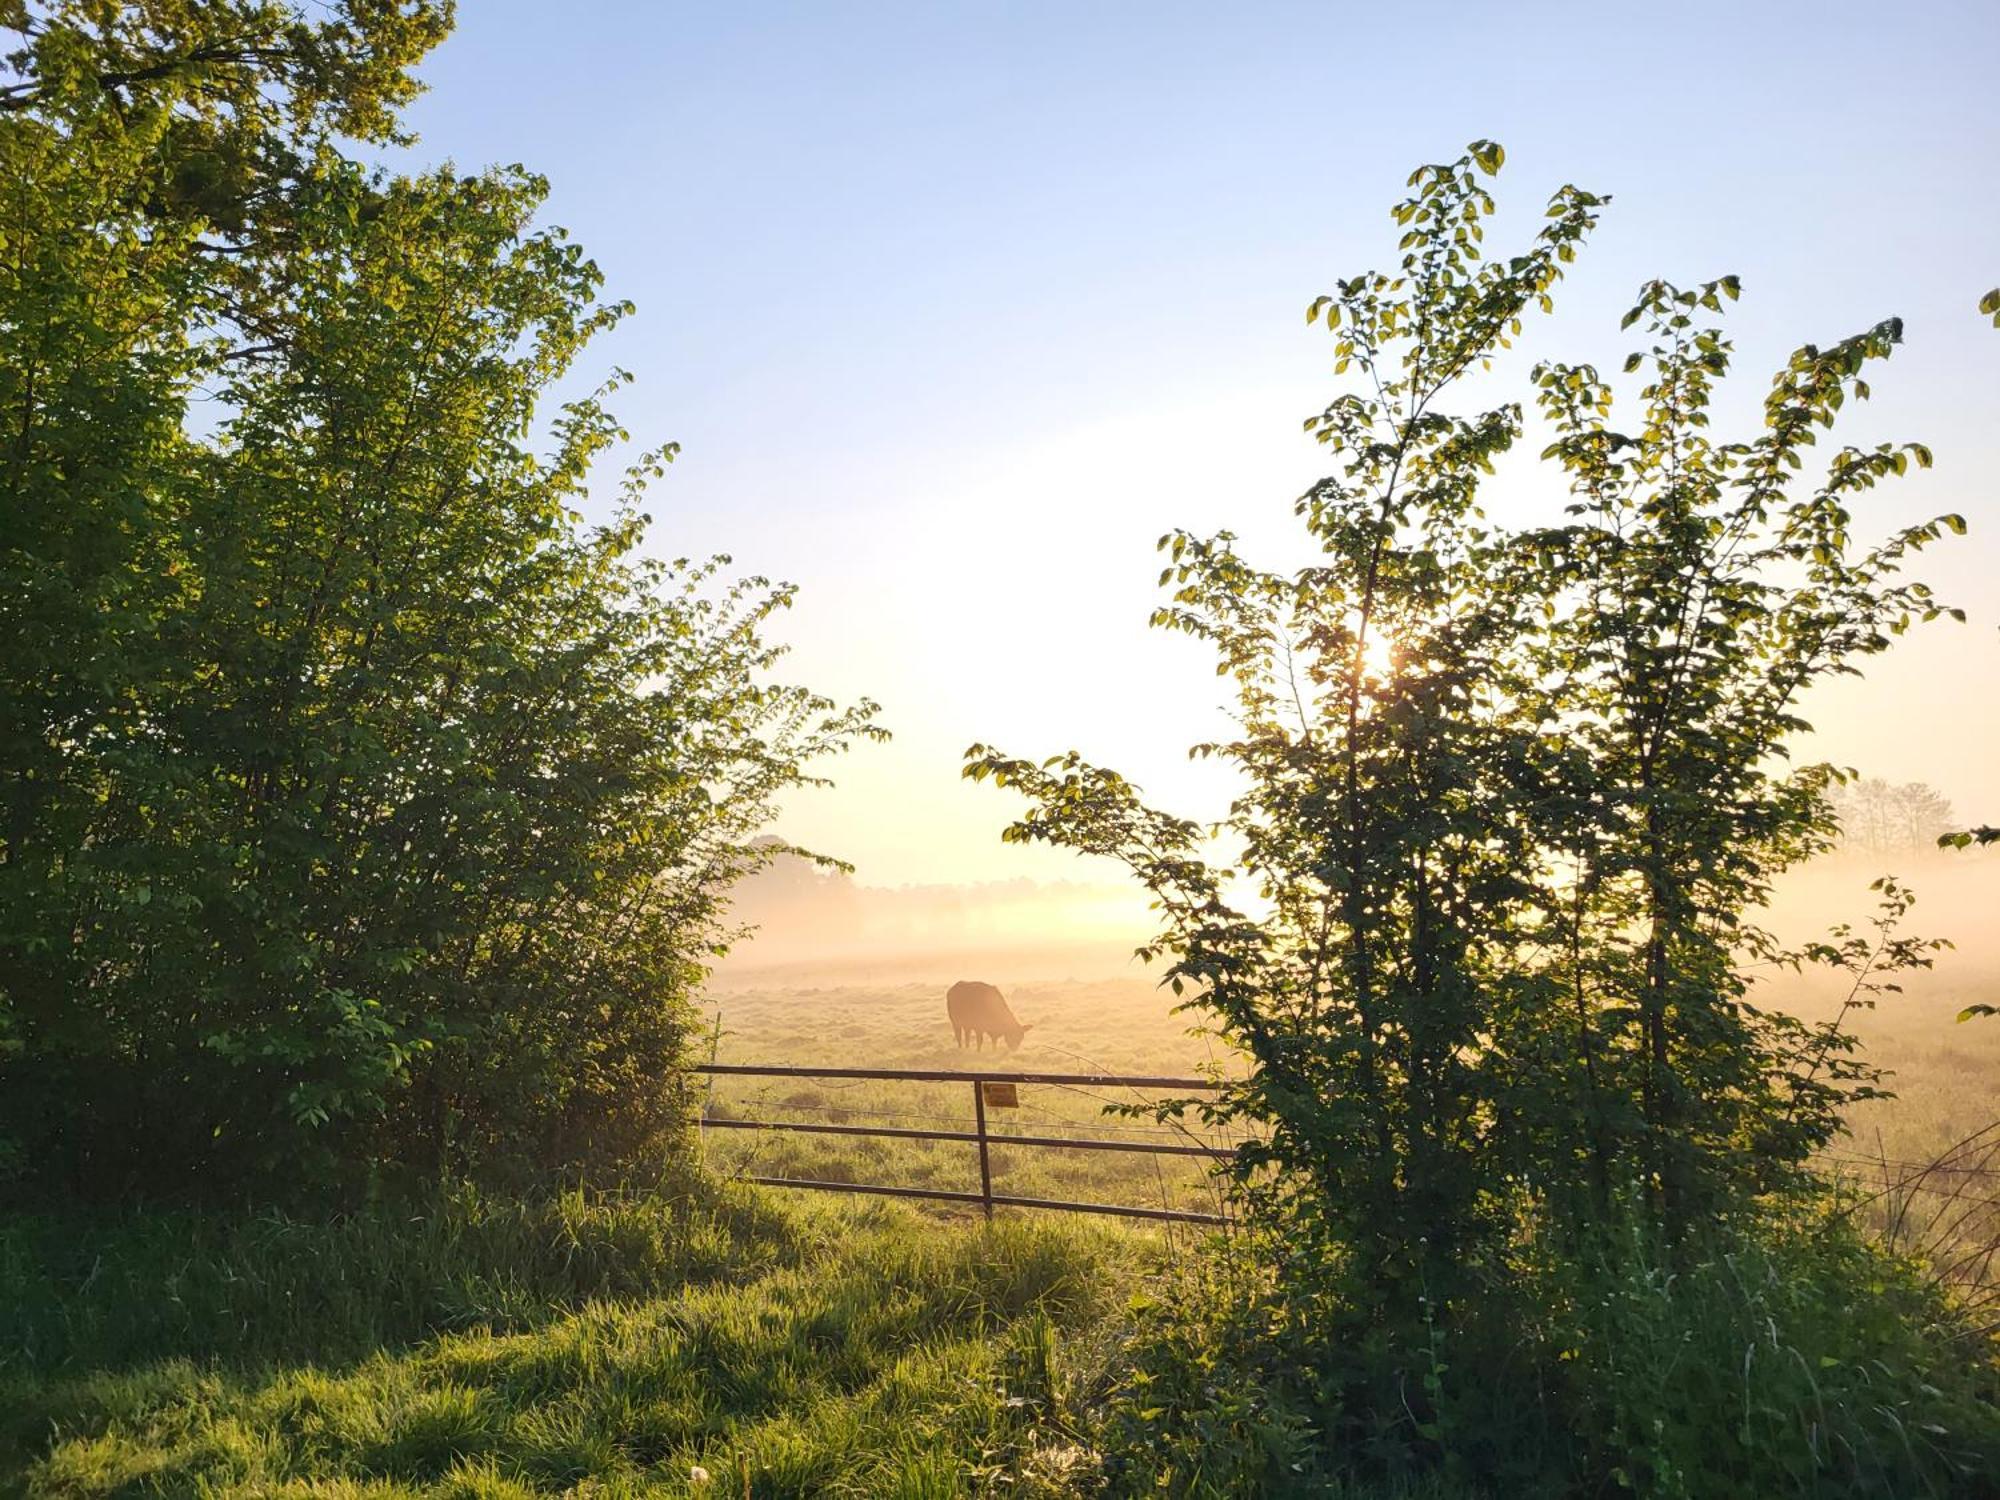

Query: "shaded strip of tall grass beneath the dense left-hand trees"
(0, 1186), (814, 1380)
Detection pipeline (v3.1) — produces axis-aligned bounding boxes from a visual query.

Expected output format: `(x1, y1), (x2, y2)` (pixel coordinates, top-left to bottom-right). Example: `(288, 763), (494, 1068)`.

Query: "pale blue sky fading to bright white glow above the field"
(382, 0), (2000, 886)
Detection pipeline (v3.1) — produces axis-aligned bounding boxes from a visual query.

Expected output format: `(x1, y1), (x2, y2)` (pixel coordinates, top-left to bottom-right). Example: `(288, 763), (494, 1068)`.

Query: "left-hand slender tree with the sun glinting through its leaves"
(968, 142), (1602, 1306)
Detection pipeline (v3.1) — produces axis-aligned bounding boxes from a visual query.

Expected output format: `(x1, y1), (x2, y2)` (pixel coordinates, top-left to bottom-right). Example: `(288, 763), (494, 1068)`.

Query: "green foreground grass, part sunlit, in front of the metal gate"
(0, 1194), (1150, 1498)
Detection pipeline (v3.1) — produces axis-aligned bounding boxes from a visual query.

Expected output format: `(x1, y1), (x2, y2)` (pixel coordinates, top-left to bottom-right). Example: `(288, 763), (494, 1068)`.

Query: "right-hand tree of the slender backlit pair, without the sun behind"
(1536, 278), (1964, 1226)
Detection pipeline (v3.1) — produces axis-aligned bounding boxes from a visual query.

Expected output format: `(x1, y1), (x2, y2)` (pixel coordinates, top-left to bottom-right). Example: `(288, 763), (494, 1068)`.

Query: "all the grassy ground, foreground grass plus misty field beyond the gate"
(0, 852), (2000, 1500)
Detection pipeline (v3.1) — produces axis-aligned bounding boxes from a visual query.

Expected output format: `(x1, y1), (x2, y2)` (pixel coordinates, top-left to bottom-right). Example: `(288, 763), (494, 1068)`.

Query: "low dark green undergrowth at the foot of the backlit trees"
(1104, 1204), (2000, 1500)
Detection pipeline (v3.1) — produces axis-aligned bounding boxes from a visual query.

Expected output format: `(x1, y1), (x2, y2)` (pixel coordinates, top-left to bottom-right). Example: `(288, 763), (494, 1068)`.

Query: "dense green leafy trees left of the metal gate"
(0, 0), (870, 1194)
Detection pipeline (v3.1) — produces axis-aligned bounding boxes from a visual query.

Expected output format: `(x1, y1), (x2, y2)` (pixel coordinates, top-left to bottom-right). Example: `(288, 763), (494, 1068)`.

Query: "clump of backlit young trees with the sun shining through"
(966, 142), (1962, 1312)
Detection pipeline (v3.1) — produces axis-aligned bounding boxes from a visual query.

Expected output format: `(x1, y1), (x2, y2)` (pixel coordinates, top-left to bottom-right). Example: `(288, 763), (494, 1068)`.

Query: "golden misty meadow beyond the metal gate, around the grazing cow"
(702, 854), (2000, 1248)
